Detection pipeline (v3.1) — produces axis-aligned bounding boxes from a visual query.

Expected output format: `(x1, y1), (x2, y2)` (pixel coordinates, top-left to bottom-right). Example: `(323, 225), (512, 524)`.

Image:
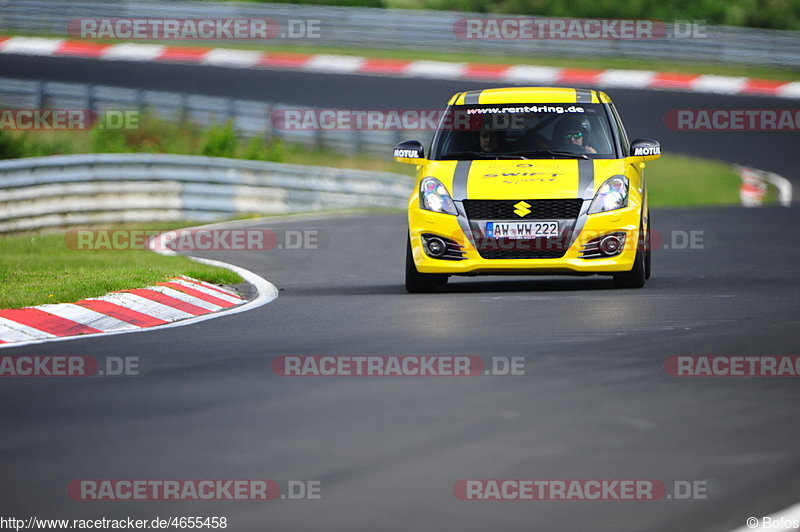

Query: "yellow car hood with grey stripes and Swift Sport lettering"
(423, 159), (626, 201)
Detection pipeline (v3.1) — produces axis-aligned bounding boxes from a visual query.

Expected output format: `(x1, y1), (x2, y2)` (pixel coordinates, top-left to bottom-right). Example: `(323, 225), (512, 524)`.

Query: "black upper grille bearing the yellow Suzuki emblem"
(463, 198), (583, 220)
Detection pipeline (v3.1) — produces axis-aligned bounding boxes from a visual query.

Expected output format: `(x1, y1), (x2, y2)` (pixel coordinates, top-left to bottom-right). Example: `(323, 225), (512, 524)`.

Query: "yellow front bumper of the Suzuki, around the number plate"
(409, 205), (641, 275)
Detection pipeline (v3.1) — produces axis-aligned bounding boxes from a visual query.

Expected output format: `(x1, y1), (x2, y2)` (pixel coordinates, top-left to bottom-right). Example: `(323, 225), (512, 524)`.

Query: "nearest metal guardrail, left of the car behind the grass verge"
(0, 154), (412, 233)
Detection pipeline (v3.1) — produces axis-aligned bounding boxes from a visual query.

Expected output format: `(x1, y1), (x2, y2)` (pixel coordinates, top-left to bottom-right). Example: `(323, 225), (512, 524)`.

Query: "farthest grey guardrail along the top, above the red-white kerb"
(0, 0), (800, 68)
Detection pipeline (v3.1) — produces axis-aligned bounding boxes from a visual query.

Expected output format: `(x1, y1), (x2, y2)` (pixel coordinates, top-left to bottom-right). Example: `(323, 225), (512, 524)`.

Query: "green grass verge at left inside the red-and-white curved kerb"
(0, 224), (242, 308)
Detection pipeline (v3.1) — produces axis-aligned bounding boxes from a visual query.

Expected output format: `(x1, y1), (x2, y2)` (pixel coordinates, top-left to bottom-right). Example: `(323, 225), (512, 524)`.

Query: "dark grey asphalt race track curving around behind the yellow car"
(0, 52), (800, 532)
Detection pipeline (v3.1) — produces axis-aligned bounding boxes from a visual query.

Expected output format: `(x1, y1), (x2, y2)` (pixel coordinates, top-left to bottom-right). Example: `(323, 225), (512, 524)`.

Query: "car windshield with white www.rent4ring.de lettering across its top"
(431, 104), (617, 160)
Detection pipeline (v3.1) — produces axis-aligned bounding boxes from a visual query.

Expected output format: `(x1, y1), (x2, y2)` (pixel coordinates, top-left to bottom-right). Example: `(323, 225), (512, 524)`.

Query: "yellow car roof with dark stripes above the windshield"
(448, 87), (611, 105)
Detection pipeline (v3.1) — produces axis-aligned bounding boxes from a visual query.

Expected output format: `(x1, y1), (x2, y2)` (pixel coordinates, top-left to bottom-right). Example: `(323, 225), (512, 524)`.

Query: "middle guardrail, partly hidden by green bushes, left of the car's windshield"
(0, 77), (422, 157)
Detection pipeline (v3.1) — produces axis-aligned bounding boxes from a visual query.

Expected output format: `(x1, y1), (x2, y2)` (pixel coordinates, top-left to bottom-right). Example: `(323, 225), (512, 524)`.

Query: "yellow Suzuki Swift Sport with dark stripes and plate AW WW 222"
(394, 87), (661, 292)
